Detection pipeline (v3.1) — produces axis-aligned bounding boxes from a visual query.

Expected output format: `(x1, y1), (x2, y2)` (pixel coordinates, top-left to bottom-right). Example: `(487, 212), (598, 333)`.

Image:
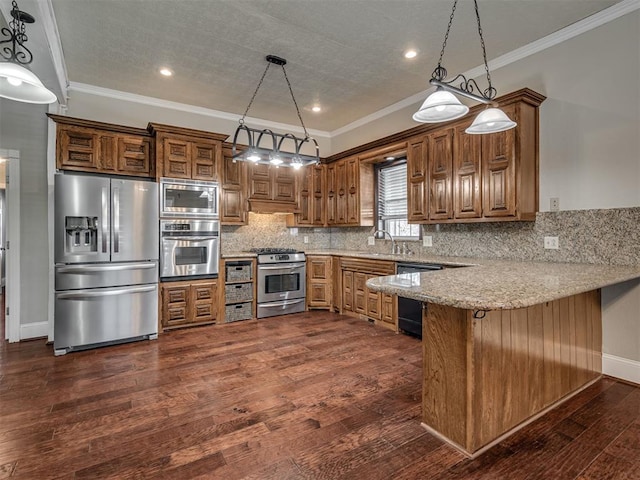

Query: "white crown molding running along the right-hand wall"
(329, 0), (640, 137)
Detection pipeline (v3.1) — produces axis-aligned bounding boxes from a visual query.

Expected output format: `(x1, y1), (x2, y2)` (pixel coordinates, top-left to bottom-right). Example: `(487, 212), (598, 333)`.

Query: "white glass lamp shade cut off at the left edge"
(0, 62), (56, 104)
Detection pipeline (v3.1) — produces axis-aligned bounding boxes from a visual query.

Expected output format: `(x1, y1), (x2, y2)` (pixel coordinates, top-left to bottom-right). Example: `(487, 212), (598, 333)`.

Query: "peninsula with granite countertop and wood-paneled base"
(367, 259), (640, 456)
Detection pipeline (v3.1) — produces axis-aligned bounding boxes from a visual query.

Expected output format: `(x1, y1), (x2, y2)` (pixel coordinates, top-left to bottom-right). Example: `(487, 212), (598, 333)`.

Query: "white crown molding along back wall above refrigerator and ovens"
(69, 82), (329, 138)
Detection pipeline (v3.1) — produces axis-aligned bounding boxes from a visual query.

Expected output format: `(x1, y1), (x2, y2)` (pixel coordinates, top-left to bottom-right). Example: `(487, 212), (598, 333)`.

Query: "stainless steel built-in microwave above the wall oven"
(160, 178), (218, 218)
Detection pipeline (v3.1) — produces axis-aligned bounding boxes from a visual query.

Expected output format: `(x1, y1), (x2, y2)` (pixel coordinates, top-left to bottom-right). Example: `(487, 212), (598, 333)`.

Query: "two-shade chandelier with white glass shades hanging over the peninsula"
(413, 0), (517, 134)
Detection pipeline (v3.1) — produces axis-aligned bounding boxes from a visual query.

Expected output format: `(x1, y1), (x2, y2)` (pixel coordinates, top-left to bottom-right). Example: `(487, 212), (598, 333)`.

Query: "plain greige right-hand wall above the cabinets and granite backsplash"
(332, 11), (640, 211)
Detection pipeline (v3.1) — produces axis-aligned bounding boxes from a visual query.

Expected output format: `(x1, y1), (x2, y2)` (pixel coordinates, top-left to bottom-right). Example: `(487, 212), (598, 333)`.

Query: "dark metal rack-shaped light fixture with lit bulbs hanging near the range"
(232, 55), (320, 169)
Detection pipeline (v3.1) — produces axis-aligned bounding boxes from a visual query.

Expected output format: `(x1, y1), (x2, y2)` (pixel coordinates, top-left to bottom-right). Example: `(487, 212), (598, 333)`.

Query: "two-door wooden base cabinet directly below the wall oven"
(160, 279), (218, 330)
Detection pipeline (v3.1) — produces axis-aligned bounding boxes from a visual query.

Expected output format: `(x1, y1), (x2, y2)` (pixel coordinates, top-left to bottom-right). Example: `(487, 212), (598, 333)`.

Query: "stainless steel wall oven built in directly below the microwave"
(160, 219), (220, 280)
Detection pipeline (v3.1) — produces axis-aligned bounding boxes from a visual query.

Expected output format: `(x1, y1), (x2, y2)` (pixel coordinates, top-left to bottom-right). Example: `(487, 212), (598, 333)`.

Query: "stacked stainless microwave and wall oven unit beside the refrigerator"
(160, 178), (220, 280)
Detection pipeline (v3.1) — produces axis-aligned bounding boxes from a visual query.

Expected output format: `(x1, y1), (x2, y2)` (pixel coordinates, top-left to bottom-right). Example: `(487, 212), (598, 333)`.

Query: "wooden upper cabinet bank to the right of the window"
(407, 89), (545, 223)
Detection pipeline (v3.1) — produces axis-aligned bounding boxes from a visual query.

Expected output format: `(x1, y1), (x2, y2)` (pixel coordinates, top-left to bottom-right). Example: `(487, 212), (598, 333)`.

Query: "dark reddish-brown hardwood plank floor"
(0, 312), (640, 480)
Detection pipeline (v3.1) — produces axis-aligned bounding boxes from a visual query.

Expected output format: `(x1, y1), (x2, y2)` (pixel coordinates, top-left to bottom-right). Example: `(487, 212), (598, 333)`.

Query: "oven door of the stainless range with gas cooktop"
(258, 263), (306, 303)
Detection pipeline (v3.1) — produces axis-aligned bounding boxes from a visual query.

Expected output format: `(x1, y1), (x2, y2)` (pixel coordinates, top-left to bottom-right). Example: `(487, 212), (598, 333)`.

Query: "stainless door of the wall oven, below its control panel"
(160, 235), (220, 279)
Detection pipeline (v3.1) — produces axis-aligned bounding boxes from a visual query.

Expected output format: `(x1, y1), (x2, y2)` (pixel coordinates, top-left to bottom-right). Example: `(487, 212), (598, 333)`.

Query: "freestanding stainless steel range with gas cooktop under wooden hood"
(252, 248), (306, 318)
